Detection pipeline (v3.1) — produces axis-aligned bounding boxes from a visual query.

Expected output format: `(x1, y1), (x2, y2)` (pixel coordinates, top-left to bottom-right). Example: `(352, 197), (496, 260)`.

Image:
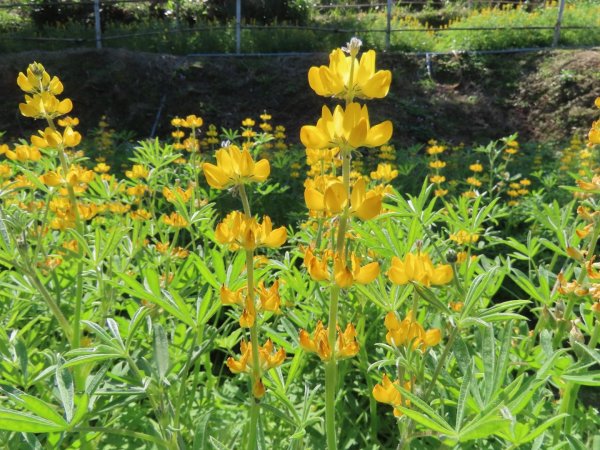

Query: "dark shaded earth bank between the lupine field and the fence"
(0, 49), (600, 146)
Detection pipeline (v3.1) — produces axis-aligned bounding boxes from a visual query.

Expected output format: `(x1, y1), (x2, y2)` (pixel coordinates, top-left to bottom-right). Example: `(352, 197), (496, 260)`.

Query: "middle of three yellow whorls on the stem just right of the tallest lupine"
(384, 310), (441, 351)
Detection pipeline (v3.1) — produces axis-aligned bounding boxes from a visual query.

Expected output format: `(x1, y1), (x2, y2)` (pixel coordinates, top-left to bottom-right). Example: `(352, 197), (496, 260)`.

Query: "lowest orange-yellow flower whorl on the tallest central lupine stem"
(299, 321), (360, 361)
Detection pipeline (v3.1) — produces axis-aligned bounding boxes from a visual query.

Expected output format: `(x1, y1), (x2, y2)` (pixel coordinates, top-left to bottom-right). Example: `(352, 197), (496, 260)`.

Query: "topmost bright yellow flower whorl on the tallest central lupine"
(308, 48), (392, 99)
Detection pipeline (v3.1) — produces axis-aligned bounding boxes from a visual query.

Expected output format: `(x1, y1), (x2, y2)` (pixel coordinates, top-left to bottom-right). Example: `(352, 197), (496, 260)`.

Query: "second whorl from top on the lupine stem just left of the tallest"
(215, 211), (287, 250)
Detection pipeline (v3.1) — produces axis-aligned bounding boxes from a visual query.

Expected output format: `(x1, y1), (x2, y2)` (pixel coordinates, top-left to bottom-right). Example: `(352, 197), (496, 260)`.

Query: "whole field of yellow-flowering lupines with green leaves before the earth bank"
(0, 38), (600, 449)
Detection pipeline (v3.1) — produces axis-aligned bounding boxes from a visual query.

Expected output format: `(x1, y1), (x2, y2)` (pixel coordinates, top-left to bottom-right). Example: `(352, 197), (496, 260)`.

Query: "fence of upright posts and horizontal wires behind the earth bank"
(0, 0), (600, 55)
